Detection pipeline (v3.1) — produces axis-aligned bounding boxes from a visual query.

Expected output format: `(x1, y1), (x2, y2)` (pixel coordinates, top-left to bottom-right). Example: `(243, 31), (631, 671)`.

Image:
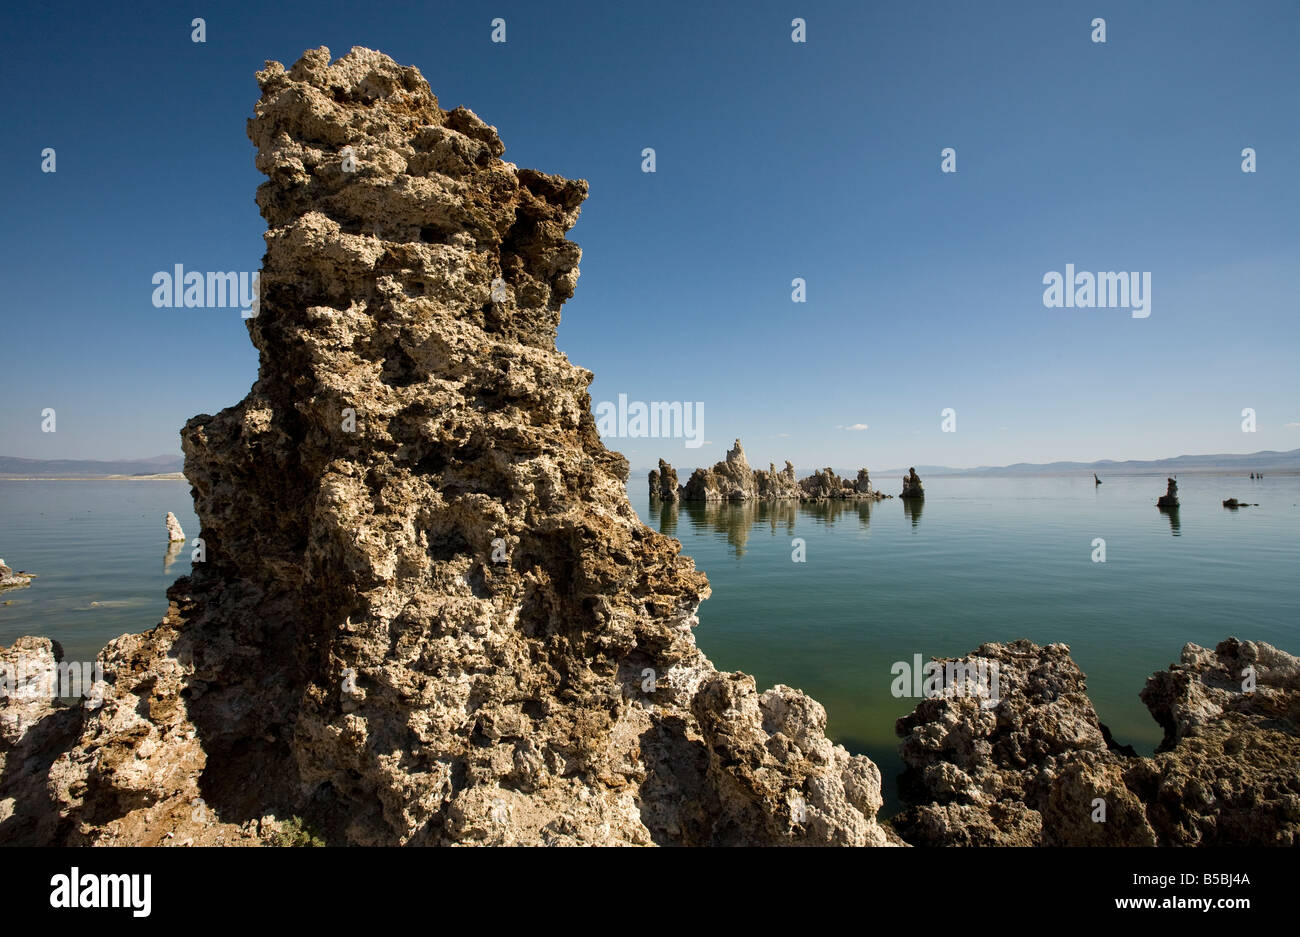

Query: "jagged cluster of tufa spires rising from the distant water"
(650, 439), (889, 502)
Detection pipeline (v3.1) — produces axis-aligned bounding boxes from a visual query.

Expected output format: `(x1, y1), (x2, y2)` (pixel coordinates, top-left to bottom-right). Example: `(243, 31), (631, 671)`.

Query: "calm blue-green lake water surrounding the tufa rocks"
(0, 473), (1300, 814)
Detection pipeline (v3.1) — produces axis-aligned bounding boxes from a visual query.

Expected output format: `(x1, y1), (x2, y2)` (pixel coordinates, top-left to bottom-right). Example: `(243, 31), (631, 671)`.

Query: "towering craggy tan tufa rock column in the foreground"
(0, 48), (896, 845)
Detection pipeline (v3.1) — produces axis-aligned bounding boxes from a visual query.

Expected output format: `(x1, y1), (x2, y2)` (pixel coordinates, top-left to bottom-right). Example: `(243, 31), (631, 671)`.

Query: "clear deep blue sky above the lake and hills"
(0, 0), (1300, 469)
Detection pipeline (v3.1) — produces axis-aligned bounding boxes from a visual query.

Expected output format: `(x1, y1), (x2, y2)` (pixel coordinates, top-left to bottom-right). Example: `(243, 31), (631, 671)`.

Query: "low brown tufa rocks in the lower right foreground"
(893, 638), (1300, 846)
